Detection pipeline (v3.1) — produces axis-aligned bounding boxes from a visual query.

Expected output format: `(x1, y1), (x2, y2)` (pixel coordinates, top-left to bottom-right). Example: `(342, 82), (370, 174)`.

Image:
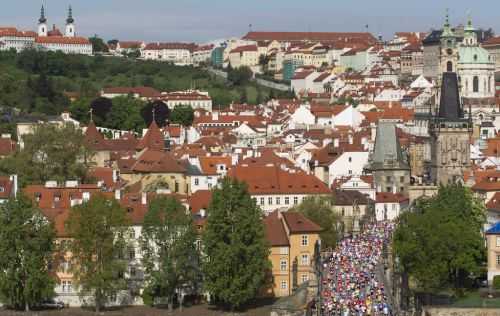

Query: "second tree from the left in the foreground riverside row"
(66, 195), (129, 312)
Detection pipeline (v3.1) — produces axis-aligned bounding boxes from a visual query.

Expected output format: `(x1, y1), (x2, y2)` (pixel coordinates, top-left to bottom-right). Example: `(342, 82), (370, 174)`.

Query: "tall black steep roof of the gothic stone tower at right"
(439, 72), (463, 121)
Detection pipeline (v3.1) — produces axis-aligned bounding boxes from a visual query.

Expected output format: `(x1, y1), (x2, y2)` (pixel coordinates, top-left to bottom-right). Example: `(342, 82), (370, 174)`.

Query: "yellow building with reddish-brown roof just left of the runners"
(264, 210), (321, 297)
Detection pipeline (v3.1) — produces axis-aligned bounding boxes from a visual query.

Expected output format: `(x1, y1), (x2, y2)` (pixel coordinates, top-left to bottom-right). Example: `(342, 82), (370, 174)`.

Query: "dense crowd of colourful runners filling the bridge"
(321, 222), (394, 316)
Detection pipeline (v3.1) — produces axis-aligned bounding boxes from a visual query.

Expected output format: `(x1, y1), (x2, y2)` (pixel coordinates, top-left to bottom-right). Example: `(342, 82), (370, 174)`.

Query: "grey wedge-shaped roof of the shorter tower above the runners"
(370, 121), (409, 170)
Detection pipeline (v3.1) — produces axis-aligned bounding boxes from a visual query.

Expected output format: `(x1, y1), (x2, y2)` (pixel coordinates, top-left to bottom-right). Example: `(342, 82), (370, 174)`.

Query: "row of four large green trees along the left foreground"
(0, 179), (270, 311)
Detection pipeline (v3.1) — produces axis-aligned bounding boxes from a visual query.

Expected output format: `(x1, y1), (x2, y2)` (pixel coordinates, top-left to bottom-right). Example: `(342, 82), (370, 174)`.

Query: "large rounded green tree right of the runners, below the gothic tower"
(394, 185), (485, 294)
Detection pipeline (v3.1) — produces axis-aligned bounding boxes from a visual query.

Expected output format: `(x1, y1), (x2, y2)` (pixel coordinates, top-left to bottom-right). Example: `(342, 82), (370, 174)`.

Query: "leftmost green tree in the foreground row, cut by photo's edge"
(0, 196), (55, 311)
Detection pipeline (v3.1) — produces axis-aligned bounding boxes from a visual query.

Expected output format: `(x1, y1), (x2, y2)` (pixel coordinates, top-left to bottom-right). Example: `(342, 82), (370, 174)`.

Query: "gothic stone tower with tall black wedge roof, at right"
(429, 72), (472, 184)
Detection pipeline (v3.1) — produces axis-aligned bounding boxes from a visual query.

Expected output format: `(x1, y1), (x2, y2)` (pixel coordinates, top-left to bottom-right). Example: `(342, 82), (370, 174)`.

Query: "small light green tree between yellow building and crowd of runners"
(294, 197), (340, 248)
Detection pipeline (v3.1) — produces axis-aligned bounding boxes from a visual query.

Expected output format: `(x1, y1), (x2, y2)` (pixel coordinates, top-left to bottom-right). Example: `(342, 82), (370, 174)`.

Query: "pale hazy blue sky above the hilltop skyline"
(0, 0), (500, 42)
